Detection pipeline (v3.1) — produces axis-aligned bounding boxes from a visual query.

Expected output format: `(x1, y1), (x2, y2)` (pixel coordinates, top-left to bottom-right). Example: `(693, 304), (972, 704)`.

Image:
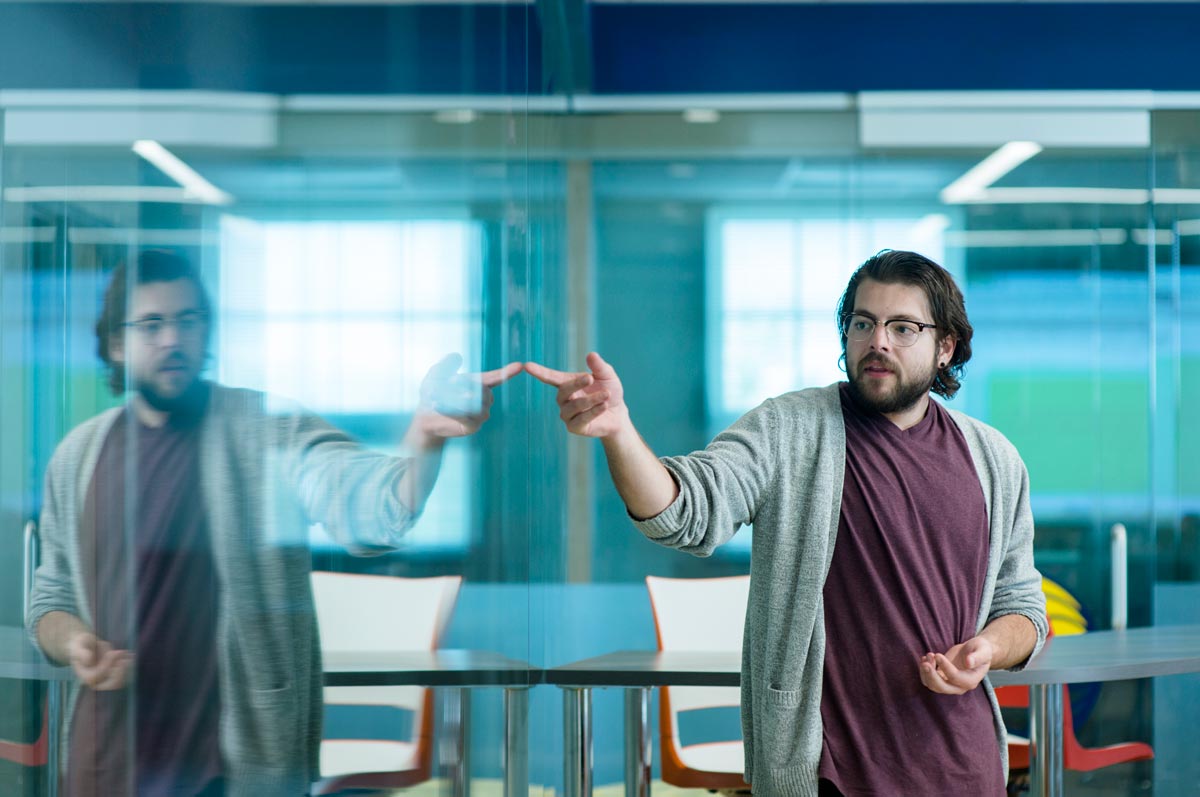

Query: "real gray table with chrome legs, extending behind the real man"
(545, 625), (1200, 797)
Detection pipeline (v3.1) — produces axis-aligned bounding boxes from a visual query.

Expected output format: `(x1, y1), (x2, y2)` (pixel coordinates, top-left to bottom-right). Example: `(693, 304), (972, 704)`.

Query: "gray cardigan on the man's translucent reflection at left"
(25, 385), (414, 797)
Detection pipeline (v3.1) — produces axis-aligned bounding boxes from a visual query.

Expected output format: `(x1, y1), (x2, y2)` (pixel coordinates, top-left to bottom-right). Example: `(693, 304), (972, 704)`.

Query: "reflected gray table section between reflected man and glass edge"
(324, 651), (541, 797)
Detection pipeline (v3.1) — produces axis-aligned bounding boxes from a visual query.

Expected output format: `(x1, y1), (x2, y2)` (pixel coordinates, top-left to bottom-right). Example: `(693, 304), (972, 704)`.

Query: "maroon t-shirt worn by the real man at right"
(820, 384), (1004, 797)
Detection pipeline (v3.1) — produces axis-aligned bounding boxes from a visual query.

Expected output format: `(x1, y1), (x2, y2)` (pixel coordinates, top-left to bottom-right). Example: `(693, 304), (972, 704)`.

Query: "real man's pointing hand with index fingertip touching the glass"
(524, 352), (630, 438)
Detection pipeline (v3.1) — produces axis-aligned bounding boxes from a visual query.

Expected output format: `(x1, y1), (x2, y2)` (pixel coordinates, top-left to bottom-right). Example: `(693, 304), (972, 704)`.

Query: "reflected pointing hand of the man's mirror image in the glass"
(414, 354), (521, 438)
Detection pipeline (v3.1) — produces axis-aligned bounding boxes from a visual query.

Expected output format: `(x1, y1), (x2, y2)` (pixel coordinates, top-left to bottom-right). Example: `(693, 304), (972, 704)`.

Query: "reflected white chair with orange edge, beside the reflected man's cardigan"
(312, 573), (462, 795)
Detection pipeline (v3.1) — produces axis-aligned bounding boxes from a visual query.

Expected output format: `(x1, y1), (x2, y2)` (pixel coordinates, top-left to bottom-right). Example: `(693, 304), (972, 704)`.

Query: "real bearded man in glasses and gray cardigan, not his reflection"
(526, 250), (1046, 797)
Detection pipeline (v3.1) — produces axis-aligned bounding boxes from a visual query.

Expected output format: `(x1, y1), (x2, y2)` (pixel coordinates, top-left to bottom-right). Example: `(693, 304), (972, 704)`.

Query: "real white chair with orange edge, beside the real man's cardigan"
(646, 576), (750, 789)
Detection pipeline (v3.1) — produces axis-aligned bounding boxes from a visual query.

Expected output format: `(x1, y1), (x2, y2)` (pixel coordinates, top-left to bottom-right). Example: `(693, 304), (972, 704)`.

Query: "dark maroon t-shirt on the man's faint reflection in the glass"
(66, 398), (222, 797)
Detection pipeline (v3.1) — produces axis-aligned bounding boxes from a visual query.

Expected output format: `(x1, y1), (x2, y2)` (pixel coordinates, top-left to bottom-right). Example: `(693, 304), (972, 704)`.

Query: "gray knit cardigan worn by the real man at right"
(635, 384), (1046, 797)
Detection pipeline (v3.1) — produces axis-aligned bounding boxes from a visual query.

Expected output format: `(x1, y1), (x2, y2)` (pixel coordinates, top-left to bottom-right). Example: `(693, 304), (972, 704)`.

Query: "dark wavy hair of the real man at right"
(838, 250), (974, 399)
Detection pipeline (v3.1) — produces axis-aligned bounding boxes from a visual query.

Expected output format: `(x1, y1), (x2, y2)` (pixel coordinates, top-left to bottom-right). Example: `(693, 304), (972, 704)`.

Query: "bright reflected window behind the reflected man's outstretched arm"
(216, 216), (482, 547)
